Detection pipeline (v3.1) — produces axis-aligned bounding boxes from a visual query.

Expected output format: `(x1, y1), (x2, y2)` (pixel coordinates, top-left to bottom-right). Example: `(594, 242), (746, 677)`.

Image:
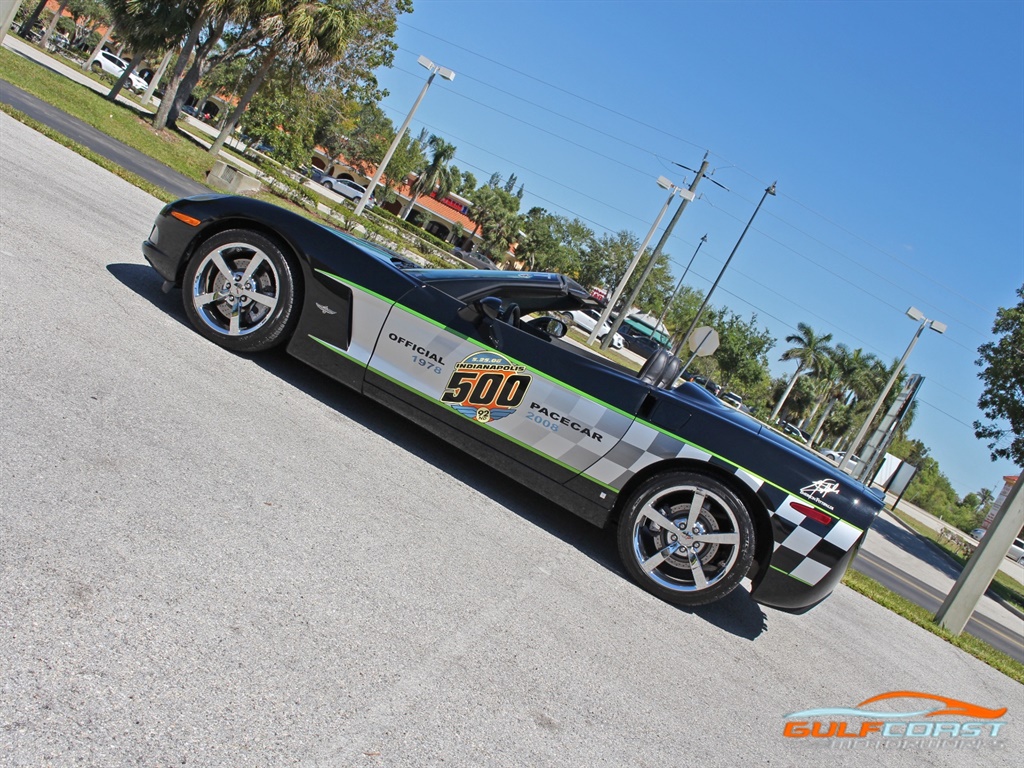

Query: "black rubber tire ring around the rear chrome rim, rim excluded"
(616, 471), (755, 606)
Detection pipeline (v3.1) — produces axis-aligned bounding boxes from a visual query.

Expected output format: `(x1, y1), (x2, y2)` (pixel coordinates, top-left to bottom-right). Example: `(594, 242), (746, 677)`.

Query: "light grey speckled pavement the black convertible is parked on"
(0, 115), (1024, 768)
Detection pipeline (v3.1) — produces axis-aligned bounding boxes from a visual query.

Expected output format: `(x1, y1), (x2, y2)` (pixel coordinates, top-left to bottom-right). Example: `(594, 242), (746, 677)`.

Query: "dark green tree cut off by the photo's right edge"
(974, 286), (1024, 466)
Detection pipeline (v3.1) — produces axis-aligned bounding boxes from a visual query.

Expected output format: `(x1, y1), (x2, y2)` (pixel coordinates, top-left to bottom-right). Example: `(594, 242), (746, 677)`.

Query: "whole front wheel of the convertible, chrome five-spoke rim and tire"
(181, 229), (301, 352)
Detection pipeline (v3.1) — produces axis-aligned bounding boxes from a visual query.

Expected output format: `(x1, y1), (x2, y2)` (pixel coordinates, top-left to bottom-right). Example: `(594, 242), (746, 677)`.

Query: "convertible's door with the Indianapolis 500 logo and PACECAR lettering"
(365, 286), (647, 483)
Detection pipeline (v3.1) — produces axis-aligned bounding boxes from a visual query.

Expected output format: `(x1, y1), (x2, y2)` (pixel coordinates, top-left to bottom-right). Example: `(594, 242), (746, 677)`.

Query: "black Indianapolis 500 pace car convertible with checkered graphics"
(142, 196), (882, 610)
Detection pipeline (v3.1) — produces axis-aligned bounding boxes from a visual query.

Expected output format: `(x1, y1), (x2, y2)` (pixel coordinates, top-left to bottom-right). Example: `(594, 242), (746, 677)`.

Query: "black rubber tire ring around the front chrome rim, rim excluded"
(181, 229), (299, 352)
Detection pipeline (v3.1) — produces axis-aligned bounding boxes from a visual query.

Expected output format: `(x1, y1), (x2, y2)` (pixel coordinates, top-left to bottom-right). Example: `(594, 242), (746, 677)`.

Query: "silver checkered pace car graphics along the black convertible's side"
(305, 281), (863, 585)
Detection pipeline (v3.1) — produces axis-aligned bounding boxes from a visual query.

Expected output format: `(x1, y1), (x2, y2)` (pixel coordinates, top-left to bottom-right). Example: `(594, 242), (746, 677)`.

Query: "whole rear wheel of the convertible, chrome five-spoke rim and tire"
(617, 472), (754, 605)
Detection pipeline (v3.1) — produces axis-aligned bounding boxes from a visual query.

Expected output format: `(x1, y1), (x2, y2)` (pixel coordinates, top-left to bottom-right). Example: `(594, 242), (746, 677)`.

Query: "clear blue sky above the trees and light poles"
(370, 0), (1024, 495)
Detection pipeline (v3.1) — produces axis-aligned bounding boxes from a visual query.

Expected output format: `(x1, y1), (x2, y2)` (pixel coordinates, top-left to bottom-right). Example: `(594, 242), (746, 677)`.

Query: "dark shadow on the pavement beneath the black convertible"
(108, 263), (767, 640)
